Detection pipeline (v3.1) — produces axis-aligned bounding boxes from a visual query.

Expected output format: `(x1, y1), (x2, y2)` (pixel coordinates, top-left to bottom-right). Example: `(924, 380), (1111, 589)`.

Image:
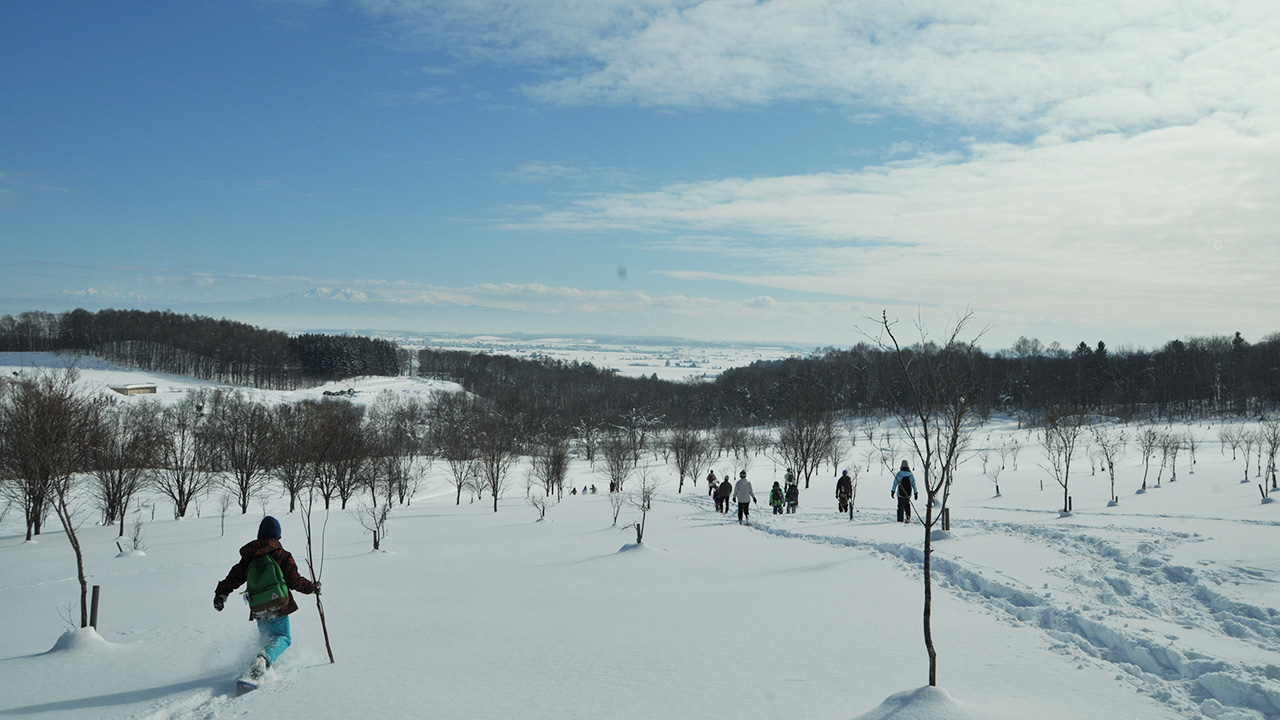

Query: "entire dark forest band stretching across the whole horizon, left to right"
(0, 304), (1280, 429)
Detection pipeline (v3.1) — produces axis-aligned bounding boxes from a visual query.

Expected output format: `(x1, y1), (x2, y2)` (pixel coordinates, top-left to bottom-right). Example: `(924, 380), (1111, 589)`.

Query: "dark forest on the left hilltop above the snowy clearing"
(0, 309), (401, 389)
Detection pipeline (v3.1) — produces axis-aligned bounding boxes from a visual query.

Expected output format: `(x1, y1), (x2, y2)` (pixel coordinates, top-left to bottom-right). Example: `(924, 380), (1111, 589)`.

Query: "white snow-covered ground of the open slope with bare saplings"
(0, 356), (1280, 720)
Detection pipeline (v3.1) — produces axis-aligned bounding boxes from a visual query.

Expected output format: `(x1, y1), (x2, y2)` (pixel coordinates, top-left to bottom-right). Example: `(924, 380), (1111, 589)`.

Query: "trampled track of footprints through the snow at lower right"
(686, 491), (1280, 717)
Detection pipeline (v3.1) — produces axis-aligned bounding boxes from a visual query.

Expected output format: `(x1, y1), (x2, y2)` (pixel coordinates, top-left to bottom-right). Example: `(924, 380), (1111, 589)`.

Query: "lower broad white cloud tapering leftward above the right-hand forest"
(504, 120), (1280, 334)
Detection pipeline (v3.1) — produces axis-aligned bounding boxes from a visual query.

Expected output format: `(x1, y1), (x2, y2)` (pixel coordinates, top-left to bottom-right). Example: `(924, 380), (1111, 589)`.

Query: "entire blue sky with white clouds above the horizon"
(0, 0), (1280, 347)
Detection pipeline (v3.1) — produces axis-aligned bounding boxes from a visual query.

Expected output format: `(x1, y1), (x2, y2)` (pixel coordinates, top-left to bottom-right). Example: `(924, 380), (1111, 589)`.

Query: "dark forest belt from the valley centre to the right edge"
(419, 333), (1280, 427)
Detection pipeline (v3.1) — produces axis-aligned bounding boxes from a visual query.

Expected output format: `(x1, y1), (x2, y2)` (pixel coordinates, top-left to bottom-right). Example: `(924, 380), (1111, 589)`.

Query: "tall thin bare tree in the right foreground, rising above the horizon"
(874, 313), (982, 687)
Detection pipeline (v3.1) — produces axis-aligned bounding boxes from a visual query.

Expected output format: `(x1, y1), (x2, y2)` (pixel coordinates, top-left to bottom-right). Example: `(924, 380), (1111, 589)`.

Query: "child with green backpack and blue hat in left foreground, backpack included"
(214, 515), (320, 680)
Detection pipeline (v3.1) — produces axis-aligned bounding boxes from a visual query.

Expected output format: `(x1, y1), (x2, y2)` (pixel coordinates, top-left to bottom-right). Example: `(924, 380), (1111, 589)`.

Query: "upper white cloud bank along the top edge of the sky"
(348, 0), (1280, 137)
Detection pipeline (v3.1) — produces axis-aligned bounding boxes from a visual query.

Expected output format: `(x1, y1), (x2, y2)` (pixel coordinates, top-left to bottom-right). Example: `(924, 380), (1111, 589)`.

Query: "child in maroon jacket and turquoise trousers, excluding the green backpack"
(214, 515), (320, 678)
